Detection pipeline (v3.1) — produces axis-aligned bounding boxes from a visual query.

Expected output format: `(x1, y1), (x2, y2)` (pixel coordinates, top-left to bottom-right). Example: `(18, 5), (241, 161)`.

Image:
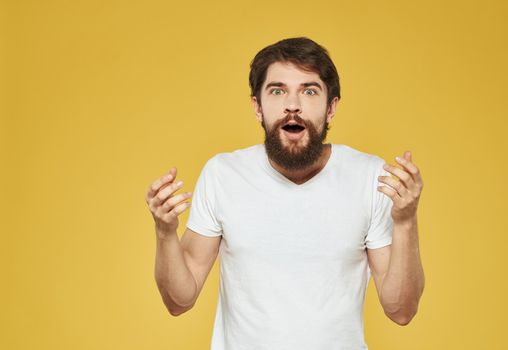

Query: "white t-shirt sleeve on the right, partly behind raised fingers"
(365, 158), (393, 249)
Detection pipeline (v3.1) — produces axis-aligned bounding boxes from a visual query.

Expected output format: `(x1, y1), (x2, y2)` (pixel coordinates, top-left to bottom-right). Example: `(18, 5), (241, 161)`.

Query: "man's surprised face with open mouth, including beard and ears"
(253, 62), (337, 170)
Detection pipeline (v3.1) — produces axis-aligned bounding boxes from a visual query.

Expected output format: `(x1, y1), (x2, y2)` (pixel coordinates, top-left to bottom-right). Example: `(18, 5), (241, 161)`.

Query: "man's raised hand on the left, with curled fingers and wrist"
(146, 167), (192, 238)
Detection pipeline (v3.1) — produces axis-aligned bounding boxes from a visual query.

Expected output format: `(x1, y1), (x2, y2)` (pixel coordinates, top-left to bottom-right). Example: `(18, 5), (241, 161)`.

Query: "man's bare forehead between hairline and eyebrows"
(263, 62), (324, 86)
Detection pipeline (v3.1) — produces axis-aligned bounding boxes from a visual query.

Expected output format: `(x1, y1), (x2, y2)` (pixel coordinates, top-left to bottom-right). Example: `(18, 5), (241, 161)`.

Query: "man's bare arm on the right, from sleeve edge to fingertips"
(367, 152), (425, 325)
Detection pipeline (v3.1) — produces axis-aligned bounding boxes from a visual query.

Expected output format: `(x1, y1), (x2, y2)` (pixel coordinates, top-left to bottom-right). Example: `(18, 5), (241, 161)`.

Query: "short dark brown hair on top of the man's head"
(249, 37), (340, 106)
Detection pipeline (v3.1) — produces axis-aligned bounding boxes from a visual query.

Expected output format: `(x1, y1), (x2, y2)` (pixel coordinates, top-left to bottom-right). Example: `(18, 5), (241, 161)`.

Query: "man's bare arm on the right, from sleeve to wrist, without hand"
(367, 218), (425, 325)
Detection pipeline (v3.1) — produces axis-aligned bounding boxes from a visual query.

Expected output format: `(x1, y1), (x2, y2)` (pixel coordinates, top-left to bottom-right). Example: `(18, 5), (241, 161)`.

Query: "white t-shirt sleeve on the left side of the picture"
(187, 157), (222, 237)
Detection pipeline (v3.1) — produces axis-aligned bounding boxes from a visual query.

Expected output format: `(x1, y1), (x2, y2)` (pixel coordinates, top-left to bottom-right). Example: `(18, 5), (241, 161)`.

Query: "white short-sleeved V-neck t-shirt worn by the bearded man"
(187, 144), (393, 350)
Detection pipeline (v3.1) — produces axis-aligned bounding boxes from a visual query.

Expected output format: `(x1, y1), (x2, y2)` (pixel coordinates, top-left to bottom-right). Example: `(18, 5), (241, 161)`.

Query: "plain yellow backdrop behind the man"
(0, 0), (508, 350)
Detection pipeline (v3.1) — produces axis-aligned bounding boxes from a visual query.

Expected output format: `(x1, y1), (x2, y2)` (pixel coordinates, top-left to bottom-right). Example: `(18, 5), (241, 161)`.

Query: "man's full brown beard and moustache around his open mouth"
(261, 113), (330, 170)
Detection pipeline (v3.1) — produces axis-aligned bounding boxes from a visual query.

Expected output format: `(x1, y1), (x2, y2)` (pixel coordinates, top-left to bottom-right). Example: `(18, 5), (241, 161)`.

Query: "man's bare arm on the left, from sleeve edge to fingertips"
(146, 167), (221, 316)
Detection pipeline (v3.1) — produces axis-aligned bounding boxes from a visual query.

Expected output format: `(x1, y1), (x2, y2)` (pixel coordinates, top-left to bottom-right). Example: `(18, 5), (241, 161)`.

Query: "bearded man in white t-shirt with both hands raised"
(146, 38), (424, 350)
